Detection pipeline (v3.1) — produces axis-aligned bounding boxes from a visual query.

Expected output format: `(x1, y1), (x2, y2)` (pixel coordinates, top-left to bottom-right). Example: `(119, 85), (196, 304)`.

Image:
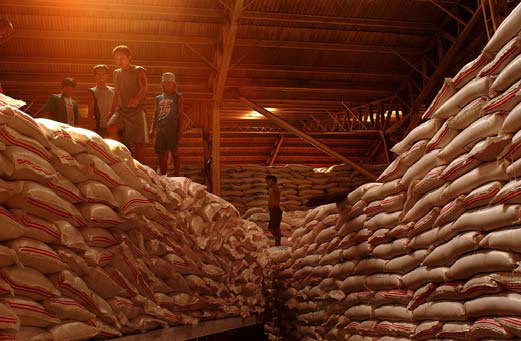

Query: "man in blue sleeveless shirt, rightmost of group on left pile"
(150, 72), (184, 176)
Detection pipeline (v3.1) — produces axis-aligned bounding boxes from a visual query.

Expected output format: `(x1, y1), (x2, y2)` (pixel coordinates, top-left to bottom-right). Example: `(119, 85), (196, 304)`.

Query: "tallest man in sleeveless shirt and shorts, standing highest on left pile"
(107, 45), (148, 162)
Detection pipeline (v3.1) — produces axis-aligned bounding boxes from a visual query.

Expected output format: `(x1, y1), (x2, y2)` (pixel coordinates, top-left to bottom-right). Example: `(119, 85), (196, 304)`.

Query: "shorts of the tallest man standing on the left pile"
(107, 109), (148, 144)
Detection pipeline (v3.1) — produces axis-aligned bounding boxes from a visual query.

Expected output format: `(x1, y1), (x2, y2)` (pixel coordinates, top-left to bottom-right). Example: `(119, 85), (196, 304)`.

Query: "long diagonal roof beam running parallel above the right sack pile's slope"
(385, 2), (483, 135)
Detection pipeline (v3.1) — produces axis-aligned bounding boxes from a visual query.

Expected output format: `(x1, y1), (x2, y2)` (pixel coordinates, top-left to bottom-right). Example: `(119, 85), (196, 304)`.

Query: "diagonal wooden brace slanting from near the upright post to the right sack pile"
(239, 96), (377, 180)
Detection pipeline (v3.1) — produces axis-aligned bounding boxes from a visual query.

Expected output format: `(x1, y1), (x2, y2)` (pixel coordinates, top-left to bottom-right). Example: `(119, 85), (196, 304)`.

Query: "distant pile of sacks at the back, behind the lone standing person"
(221, 165), (381, 213)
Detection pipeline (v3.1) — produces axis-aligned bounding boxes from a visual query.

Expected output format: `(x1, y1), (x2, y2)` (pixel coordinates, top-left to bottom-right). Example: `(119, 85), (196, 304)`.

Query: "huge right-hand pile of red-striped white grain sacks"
(272, 5), (521, 341)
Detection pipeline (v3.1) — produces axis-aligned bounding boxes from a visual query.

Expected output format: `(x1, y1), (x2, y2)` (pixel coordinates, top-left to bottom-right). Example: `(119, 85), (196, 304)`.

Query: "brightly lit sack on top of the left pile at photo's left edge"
(0, 107), (51, 148)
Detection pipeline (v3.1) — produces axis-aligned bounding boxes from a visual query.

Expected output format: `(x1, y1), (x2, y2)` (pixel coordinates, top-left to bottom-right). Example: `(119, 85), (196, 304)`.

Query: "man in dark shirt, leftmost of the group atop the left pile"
(44, 77), (79, 126)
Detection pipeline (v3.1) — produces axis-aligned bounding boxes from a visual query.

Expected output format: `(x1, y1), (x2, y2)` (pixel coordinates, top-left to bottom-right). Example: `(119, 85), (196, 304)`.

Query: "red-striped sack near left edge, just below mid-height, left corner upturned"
(6, 181), (85, 226)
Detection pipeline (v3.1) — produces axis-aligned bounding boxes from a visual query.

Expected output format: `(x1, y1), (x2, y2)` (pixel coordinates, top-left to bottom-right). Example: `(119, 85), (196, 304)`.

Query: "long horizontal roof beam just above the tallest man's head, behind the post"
(13, 29), (422, 55)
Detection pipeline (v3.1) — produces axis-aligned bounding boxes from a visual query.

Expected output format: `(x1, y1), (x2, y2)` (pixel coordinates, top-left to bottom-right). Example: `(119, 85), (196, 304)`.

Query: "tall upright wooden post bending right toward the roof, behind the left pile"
(212, 0), (244, 195)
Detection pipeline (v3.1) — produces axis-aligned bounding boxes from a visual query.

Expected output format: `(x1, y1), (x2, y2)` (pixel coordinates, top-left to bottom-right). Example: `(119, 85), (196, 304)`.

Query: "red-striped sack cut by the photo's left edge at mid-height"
(2, 146), (58, 184)
